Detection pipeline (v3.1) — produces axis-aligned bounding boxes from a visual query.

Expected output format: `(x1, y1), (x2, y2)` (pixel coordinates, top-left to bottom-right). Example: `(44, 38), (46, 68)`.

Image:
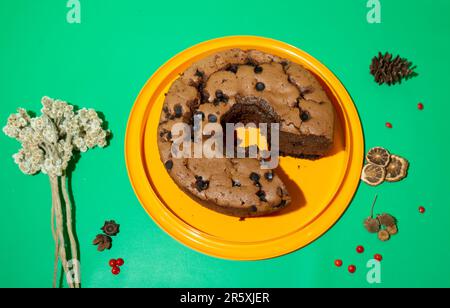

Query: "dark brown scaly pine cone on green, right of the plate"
(370, 52), (417, 86)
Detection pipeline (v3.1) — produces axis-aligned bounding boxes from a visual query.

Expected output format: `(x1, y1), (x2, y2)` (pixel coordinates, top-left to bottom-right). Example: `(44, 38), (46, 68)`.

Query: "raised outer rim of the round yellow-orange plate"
(124, 36), (364, 260)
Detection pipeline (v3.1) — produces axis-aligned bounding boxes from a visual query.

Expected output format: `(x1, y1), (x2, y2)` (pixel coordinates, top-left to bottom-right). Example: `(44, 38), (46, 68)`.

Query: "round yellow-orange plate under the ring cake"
(125, 36), (364, 260)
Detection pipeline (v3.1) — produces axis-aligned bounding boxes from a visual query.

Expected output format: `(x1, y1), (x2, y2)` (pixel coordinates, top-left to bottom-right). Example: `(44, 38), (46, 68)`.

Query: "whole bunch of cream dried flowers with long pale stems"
(3, 97), (109, 288)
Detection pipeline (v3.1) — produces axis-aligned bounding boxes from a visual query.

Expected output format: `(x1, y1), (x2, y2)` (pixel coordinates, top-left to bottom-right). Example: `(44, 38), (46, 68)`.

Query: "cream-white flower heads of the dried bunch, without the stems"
(3, 97), (109, 176)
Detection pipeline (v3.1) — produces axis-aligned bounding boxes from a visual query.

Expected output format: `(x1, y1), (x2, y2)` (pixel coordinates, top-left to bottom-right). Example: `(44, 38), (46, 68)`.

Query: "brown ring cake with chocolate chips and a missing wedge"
(158, 49), (335, 217)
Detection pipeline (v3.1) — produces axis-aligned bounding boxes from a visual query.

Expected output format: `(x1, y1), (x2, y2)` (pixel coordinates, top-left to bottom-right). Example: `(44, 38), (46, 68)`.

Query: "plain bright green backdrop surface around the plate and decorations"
(0, 0), (450, 287)
